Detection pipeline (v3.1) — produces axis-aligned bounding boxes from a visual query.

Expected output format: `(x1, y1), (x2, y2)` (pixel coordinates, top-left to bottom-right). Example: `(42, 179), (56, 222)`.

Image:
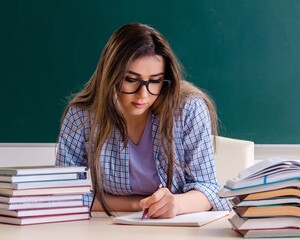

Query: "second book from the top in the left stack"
(0, 173), (78, 183)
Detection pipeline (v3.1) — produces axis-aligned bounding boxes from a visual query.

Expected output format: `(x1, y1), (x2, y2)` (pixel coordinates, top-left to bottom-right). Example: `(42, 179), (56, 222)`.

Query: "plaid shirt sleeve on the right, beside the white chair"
(182, 99), (231, 210)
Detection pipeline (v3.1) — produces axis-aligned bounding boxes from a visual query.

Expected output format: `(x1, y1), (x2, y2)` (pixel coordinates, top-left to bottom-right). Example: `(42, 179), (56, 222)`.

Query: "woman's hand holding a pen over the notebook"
(140, 188), (178, 218)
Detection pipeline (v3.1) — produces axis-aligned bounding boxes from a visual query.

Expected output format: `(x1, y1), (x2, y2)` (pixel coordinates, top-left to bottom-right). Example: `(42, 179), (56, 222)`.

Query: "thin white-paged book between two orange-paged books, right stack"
(229, 196), (300, 207)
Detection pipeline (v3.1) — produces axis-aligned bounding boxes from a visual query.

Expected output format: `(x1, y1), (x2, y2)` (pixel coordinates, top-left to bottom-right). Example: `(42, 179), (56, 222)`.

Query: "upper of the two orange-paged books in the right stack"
(234, 187), (300, 201)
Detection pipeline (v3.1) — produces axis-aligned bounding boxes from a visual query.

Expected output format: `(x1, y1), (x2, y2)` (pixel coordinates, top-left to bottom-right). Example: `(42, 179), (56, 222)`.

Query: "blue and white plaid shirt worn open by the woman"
(56, 98), (230, 210)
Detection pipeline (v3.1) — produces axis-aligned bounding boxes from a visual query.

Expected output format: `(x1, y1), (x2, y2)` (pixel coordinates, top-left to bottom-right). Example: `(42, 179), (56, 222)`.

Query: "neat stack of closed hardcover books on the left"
(0, 166), (91, 225)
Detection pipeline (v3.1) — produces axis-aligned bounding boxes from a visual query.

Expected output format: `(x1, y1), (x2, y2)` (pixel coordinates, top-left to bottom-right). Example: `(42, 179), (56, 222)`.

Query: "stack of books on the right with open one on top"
(219, 158), (300, 238)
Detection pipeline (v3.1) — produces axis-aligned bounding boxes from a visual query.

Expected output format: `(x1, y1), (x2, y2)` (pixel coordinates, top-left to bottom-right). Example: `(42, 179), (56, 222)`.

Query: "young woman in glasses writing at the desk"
(56, 23), (230, 218)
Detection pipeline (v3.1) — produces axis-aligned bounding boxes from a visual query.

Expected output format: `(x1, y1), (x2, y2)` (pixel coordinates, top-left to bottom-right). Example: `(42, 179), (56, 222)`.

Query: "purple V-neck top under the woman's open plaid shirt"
(128, 113), (160, 195)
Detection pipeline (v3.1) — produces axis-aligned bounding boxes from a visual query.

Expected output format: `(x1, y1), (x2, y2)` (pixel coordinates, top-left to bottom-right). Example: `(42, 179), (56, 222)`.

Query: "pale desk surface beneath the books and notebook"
(0, 217), (296, 240)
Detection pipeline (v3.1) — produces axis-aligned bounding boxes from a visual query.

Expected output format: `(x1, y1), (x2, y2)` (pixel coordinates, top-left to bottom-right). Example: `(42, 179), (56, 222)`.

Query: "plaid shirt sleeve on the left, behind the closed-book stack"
(55, 107), (93, 206)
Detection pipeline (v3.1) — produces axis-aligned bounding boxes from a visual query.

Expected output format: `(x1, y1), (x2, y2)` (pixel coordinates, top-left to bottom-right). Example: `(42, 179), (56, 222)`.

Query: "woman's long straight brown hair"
(63, 23), (216, 215)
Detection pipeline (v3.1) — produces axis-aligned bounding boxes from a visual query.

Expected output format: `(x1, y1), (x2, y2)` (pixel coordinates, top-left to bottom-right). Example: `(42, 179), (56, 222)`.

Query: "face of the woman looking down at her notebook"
(118, 55), (165, 120)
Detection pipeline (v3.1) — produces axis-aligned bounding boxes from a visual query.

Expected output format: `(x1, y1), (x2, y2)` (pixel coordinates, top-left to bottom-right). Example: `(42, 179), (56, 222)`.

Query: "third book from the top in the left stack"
(0, 179), (91, 189)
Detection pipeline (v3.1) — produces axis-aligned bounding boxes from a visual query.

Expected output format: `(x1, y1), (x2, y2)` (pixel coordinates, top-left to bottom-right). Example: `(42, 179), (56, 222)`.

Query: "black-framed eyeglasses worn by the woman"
(121, 77), (171, 96)
